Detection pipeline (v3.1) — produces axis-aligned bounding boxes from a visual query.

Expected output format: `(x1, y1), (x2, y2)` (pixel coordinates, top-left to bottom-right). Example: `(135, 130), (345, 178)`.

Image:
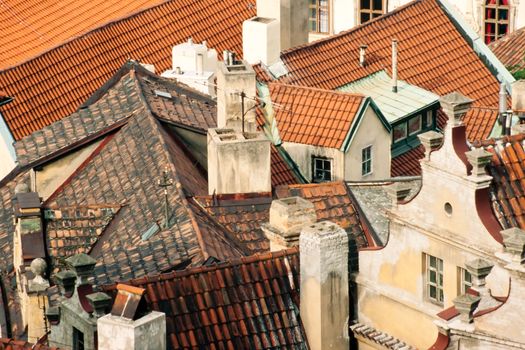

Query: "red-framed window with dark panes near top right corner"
(483, 0), (510, 44)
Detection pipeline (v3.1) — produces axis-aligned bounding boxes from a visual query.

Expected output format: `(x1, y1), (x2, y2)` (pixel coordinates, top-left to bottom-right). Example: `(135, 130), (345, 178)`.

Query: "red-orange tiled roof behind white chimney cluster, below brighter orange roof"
(0, 0), (255, 140)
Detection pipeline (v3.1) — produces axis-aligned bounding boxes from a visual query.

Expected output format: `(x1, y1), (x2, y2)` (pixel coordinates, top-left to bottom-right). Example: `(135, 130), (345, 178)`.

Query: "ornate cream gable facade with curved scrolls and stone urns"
(354, 93), (509, 349)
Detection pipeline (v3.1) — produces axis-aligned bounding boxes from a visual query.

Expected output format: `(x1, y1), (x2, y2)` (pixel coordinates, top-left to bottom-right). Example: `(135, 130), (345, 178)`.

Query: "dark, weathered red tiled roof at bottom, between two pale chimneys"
(103, 248), (307, 349)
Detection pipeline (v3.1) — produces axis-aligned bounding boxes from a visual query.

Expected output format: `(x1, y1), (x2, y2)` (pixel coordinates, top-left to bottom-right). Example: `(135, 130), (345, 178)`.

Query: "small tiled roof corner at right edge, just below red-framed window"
(489, 27), (525, 73)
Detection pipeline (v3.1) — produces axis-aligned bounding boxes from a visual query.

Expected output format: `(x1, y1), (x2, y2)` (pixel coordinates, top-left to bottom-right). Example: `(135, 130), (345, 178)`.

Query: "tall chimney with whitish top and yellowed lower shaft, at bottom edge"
(299, 221), (350, 350)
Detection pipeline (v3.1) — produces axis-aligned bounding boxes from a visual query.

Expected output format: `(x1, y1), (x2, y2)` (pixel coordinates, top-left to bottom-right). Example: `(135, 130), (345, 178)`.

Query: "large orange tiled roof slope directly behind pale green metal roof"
(281, 0), (499, 140)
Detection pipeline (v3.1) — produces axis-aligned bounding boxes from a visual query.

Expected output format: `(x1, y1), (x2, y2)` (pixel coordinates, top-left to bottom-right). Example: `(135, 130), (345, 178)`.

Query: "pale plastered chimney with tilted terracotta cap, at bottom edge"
(97, 284), (166, 350)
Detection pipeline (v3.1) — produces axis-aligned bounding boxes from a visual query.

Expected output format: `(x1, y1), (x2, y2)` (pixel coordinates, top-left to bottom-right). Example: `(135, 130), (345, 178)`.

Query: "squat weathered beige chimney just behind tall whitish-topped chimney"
(261, 197), (317, 252)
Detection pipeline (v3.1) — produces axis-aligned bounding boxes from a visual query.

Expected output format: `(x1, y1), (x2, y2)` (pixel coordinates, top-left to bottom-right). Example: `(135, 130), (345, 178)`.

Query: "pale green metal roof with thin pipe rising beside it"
(337, 71), (439, 124)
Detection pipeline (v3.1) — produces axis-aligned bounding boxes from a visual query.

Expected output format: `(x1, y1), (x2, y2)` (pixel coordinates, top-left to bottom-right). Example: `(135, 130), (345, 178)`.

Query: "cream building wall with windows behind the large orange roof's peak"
(308, 0), (525, 43)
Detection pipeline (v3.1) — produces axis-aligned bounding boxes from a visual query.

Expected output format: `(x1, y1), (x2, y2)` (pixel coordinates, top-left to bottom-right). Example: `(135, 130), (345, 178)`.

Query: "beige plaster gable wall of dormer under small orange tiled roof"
(344, 107), (391, 180)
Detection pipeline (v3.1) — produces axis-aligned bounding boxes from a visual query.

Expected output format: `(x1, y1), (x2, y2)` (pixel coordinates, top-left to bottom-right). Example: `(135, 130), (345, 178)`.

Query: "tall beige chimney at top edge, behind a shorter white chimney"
(257, 0), (308, 51)
